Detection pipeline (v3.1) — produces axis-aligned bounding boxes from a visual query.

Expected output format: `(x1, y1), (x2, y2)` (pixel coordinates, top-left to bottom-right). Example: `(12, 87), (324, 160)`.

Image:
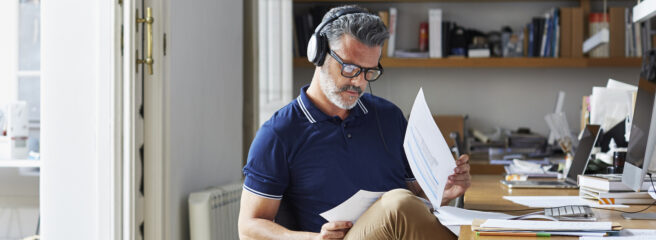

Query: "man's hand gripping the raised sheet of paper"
(442, 154), (471, 205)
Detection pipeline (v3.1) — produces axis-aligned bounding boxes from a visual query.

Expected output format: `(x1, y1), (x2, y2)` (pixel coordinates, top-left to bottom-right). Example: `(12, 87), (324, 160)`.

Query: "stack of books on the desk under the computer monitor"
(578, 174), (654, 205)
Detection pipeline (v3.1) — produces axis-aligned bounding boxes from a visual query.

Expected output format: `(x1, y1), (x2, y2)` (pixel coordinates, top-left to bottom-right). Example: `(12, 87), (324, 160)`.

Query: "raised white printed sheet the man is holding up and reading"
(403, 89), (456, 209)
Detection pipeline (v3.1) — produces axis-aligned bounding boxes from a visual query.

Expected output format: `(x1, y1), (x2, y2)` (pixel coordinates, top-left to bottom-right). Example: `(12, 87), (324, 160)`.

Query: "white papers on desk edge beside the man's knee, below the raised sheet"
(433, 206), (515, 226)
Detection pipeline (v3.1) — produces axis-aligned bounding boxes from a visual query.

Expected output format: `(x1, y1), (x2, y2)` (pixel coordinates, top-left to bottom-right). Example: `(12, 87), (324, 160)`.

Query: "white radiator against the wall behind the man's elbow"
(189, 182), (242, 240)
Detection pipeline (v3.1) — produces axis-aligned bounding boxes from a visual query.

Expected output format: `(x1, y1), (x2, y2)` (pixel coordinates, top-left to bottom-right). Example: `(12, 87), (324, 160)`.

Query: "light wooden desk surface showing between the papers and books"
(459, 175), (656, 240)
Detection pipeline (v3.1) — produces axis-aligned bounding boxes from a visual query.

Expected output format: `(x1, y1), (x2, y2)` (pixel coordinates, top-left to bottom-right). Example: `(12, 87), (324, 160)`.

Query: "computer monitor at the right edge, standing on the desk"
(622, 77), (656, 191)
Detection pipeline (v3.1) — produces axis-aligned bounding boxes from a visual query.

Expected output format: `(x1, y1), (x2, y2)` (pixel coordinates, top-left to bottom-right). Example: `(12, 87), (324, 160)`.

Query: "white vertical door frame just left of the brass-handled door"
(96, 1), (124, 239)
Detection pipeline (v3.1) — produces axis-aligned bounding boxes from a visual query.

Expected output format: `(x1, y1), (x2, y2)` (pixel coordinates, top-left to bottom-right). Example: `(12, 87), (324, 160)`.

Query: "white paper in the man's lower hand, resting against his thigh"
(319, 190), (385, 223)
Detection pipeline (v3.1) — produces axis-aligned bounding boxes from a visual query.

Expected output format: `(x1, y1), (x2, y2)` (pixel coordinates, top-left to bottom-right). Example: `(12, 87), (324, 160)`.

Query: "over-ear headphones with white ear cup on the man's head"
(307, 8), (369, 67)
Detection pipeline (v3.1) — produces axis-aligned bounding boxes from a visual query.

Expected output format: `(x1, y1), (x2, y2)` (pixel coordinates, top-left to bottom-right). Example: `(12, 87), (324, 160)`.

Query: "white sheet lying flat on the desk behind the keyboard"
(503, 196), (629, 208)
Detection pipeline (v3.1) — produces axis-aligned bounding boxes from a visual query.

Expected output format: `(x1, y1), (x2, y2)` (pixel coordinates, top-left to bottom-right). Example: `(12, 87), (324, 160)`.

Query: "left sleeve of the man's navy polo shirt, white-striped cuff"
(243, 124), (289, 200)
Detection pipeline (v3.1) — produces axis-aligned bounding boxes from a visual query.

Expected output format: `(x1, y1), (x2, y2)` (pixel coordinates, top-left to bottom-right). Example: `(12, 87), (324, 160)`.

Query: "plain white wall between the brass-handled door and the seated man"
(166, 0), (243, 239)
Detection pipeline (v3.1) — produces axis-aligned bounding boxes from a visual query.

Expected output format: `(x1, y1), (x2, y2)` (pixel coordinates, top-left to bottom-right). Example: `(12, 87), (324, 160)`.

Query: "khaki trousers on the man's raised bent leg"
(344, 189), (457, 240)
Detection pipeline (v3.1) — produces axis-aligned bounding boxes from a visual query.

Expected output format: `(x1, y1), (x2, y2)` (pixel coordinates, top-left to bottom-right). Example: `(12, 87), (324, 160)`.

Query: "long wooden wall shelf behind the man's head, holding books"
(294, 58), (642, 68)
